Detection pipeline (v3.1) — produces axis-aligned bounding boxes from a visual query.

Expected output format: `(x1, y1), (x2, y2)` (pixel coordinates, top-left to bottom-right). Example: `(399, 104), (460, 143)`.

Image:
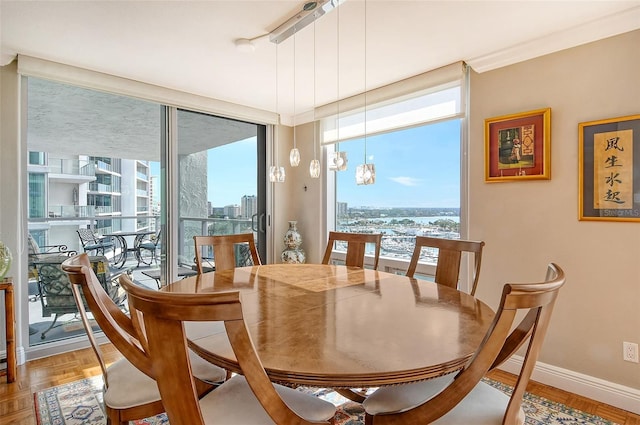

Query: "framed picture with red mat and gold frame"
(484, 108), (551, 182)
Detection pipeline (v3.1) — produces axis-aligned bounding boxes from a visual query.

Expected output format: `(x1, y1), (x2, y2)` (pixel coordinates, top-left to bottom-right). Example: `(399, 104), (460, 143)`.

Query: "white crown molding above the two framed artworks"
(466, 6), (640, 73)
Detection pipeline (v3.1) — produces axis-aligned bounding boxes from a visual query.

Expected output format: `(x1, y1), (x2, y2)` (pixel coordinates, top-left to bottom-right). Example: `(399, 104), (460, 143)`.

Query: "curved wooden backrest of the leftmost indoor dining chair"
(62, 254), (153, 385)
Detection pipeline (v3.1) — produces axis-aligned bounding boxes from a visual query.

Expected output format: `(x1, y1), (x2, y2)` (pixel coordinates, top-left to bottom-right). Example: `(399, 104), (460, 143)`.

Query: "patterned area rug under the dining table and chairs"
(34, 376), (615, 425)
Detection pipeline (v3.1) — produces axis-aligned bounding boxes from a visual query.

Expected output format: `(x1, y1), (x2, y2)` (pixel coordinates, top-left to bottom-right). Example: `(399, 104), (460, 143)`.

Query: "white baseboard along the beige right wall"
(500, 356), (640, 415)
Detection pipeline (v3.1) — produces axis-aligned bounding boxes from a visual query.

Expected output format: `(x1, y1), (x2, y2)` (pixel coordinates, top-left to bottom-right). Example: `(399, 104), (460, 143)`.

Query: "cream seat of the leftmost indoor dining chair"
(104, 351), (227, 410)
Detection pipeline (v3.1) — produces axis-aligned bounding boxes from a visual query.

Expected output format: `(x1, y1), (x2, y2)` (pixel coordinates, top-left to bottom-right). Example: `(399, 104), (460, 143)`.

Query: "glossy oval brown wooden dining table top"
(163, 264), (494, 388)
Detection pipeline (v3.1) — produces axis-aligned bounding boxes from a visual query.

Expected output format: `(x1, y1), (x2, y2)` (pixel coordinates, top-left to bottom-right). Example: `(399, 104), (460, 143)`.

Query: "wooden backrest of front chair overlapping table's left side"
(120, 276), (311, 425)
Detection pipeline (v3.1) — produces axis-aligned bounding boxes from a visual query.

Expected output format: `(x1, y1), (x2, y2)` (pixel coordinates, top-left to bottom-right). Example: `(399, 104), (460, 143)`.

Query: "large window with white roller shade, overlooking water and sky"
(322, 71), (464, 269)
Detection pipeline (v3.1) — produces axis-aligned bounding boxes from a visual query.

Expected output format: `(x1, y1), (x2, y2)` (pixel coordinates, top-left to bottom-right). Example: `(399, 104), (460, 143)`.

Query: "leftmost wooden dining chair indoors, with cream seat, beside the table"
(62, 254), (227, 425)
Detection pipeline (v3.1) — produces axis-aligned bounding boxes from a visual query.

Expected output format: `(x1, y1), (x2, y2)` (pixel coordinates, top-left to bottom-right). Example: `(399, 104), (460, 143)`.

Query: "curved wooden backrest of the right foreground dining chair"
(384, 263), (565, 424)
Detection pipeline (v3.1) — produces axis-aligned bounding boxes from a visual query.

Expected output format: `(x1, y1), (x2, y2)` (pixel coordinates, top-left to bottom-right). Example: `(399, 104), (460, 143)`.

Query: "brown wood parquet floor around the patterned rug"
(0, 344), (640, 425)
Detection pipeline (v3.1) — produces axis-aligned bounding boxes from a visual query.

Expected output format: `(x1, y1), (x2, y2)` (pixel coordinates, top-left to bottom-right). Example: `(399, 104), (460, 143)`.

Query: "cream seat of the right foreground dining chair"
(362, 375), (524, 425)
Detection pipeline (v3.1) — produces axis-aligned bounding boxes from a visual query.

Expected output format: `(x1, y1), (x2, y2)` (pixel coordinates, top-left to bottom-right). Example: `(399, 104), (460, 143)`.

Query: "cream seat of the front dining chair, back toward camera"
(200, 375), (336, 425)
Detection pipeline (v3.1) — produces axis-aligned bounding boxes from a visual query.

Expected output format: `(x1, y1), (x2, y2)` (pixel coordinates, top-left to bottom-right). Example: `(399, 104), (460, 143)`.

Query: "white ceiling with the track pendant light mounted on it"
(0, 0), (640, 124)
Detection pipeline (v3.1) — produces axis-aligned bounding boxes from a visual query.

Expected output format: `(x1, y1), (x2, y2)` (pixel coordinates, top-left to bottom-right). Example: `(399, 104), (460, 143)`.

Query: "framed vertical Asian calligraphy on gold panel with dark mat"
(578, 115), (640, 221)
